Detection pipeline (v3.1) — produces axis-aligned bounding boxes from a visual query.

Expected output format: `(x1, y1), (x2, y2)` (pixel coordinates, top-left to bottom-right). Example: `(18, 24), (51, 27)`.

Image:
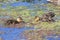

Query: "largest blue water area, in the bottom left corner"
(0, 28), (34, 40)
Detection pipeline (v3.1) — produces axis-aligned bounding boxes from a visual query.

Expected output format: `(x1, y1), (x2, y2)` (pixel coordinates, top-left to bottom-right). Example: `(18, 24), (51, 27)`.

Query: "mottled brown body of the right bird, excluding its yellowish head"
(41, 12), (55, 22)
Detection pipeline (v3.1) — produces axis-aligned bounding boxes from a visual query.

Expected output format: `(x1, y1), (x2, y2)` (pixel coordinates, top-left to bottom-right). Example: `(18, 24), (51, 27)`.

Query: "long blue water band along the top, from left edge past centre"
(1, 0), (47, 8)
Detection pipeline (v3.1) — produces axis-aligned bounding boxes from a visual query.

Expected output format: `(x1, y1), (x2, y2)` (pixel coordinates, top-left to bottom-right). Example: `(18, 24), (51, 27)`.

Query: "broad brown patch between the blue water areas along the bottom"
(23, 29), (60, 40)
